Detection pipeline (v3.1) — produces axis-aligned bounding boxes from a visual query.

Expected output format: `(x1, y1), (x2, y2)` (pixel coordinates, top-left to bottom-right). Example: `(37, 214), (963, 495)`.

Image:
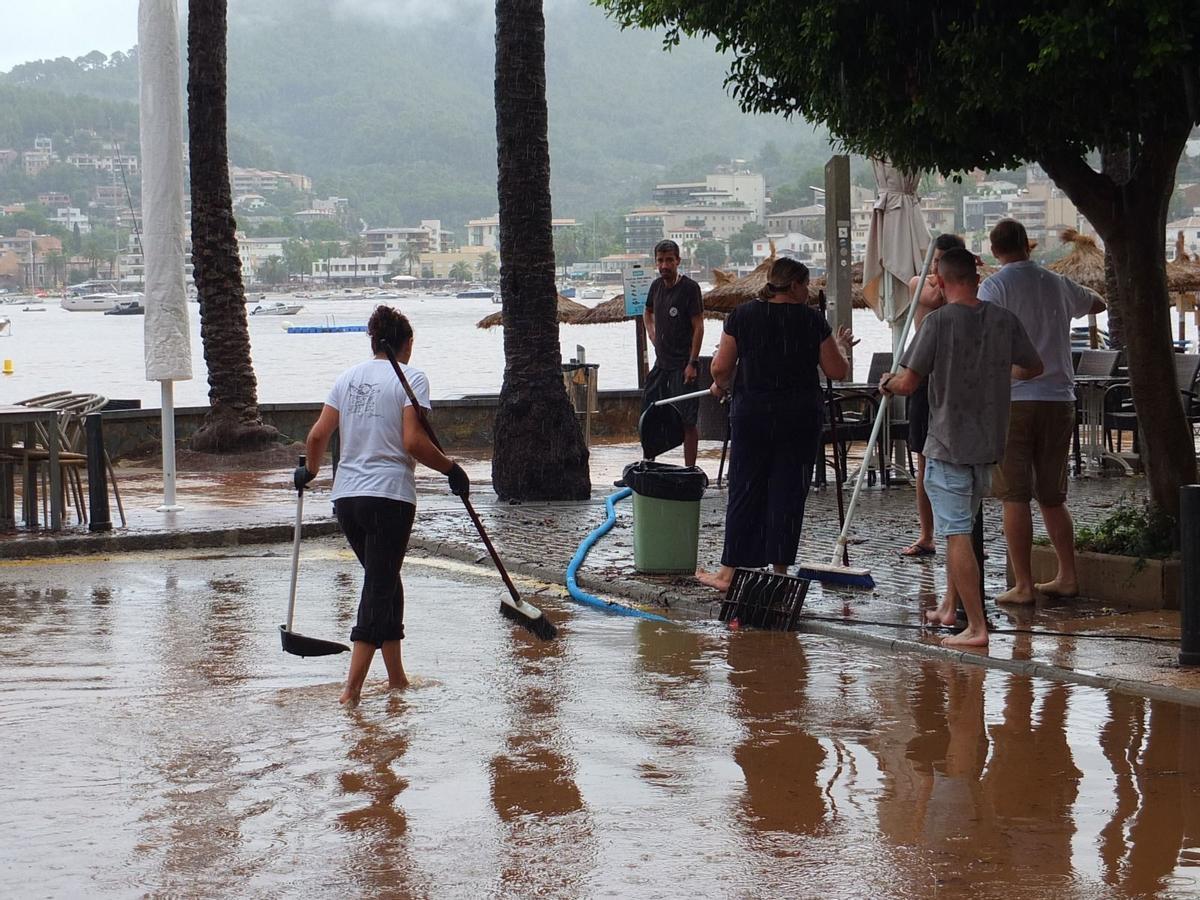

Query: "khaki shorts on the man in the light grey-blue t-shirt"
(991, 400), (1075, 506)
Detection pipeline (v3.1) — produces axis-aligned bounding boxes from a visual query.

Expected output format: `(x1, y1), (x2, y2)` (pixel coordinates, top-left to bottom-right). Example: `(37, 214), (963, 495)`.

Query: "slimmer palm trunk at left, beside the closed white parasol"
(187, 0), (278, 452)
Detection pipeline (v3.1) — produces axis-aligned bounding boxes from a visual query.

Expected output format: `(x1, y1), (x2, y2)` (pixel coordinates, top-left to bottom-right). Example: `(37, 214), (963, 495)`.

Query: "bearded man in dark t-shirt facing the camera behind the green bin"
(642, 240), (704, 466)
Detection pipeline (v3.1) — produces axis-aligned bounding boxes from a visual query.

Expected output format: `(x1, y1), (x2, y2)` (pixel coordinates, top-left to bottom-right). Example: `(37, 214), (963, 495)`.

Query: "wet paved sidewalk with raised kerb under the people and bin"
(0, 444), (1200, 706)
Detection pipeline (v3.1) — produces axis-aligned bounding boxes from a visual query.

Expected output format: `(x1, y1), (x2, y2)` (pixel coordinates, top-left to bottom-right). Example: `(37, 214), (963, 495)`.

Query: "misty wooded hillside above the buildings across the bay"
(0, 0), (828, 227)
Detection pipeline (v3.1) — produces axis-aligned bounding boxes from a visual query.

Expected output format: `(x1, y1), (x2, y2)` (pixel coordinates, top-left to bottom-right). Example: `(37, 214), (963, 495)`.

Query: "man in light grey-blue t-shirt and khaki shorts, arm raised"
(979, 218), (1108, 604)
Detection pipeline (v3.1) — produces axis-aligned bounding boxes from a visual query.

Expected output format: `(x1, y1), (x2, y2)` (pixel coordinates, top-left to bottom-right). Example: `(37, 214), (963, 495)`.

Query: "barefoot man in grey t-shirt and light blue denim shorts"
(880, 250), (1042, 647)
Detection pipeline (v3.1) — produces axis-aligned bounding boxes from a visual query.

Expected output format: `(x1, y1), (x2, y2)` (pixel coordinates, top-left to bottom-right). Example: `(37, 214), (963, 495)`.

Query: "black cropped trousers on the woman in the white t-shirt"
(334, 497), (416, 648)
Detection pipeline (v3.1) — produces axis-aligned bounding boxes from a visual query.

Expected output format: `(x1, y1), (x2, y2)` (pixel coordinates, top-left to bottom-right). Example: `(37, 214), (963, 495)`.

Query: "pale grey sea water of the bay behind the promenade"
(0, 293), (1123, 407)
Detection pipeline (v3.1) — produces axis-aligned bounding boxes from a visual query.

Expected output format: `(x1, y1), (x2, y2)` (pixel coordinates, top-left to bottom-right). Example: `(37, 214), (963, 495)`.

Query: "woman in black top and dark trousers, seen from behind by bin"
(696, 258), (853, 590)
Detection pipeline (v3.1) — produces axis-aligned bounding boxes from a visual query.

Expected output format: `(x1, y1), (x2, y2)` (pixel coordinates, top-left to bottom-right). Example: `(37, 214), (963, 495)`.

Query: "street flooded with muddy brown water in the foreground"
(0, 540), (1200, 898)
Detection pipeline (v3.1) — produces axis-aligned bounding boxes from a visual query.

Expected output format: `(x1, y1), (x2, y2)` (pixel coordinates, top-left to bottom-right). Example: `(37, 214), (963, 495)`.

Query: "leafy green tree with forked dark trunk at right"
(600, 0), (1200, 511)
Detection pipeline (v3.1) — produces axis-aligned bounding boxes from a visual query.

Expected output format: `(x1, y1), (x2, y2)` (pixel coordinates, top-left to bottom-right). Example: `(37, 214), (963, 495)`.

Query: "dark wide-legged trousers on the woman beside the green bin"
(721, 406), (822, 569)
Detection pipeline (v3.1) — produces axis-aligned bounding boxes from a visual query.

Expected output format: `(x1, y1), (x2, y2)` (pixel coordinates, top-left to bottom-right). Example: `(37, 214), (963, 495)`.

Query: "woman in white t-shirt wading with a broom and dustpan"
(295, 306), (470, 706)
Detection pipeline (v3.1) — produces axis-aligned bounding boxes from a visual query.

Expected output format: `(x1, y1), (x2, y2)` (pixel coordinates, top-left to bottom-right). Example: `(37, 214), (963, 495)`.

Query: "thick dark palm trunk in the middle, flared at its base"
(492, 0), (592, 500)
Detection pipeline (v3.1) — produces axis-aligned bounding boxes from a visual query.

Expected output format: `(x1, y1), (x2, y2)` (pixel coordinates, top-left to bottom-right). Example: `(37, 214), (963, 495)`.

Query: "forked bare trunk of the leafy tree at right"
(1040, 124), (1196, 518)
